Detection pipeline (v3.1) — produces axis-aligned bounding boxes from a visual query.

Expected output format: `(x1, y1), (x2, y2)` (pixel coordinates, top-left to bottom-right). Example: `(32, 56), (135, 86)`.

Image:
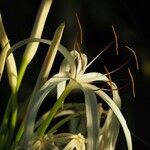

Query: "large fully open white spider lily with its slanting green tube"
(20, 46), (132, 150)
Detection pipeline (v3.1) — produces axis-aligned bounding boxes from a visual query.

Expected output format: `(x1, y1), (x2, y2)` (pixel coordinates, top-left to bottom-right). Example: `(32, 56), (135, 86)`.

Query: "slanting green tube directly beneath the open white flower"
(37, 81), (76, 137)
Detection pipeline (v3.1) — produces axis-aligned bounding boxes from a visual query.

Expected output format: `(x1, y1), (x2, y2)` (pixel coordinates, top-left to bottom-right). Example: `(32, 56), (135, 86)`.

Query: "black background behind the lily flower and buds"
(0, 0), (150, 150)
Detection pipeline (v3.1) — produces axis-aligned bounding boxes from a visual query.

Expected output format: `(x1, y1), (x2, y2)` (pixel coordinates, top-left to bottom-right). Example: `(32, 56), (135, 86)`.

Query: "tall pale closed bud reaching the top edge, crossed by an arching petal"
(16, 0), (52, 91)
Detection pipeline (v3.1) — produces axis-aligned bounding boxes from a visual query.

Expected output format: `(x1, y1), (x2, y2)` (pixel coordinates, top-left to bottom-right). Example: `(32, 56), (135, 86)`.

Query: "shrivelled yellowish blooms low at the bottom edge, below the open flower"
(23, 133), (86, 150)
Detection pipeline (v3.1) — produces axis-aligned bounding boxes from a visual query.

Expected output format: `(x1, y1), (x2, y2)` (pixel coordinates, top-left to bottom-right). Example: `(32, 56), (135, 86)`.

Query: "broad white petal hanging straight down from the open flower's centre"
(83, 87), (99, 150)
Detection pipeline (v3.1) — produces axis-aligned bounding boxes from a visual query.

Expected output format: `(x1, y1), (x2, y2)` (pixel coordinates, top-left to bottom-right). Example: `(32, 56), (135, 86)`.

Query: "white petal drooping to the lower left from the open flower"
(24, 73), (68, 142)
